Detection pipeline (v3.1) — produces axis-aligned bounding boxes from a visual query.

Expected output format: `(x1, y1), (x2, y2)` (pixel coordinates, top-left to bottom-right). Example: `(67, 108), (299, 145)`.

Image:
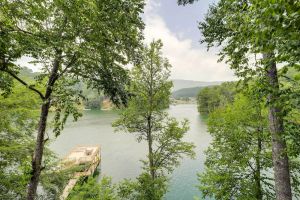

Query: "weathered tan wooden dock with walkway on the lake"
(60, 146), (101, 200)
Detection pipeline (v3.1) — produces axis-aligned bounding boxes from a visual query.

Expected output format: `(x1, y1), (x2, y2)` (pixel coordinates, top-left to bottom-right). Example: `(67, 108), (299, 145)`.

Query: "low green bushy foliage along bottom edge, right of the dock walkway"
(68, 173), (167, 200)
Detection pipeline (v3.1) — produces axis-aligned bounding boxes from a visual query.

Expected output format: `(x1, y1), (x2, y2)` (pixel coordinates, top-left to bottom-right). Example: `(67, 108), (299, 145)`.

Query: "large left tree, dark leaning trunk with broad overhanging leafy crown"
(0, 0), (144, 199)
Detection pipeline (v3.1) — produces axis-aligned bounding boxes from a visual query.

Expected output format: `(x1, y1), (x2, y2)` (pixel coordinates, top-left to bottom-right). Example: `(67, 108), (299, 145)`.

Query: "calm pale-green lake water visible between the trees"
(50, 105), (210, 200)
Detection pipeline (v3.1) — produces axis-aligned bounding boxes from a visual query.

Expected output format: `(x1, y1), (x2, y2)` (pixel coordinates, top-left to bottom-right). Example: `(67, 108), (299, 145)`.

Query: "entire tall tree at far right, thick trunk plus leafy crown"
(178, 0), (300, 200)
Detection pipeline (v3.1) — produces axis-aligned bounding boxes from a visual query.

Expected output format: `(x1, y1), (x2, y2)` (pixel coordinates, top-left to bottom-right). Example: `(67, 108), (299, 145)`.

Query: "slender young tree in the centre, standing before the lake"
(114, 41), (194, 200)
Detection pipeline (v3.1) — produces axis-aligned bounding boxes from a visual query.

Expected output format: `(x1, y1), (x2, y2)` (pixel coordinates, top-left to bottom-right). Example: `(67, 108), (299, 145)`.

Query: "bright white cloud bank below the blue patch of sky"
(144, 0), (234, 81)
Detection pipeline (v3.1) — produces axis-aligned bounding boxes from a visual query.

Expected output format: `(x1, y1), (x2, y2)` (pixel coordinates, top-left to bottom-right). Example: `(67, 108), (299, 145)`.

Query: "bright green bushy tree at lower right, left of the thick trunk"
(199, 94), (274, 200)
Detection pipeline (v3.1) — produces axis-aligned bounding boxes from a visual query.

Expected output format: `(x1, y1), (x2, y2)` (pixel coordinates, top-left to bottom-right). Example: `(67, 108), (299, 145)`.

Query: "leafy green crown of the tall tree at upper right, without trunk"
(199, 0), (300, 82)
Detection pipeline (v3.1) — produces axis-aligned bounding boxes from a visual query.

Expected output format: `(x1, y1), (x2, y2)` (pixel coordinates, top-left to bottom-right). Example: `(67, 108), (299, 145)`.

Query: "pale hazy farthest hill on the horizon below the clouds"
(172, 79), (222, 92)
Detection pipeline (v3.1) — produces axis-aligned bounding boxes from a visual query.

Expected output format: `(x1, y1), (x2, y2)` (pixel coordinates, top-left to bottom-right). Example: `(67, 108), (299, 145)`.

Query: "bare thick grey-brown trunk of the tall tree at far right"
(263, 53), (292, 200)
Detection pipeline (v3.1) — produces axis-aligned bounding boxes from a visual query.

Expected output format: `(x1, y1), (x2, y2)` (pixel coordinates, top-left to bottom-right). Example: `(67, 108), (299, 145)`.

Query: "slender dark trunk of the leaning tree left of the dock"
(27, 53), (61, 200)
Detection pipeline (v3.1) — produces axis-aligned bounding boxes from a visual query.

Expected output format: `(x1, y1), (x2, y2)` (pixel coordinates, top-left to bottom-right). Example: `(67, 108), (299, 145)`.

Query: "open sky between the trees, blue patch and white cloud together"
(143, 0), (234, 81)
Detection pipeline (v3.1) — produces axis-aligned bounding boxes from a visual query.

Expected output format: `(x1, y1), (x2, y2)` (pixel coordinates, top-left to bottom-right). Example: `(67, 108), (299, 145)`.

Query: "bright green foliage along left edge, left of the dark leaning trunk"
(0, 83), (39, 199)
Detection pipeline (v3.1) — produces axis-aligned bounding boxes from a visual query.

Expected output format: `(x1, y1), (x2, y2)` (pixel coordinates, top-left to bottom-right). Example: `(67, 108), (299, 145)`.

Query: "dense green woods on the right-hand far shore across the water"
(197, 82), (237, 114)
